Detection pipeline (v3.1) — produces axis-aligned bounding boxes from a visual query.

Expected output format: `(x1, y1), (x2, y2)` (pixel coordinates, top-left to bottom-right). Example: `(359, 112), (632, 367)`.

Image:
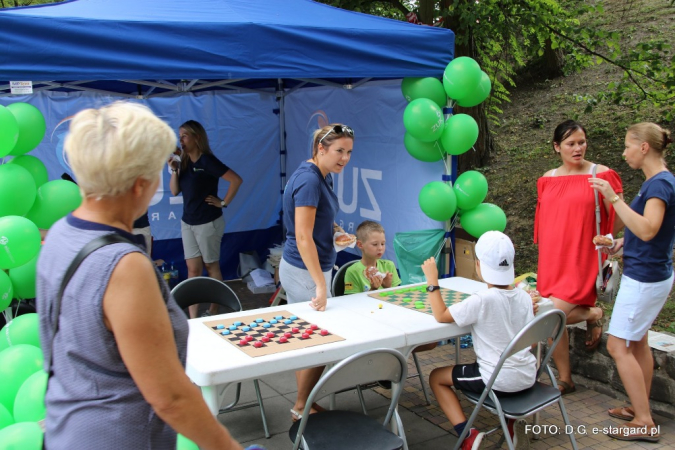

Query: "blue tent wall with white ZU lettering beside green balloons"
(286, 81), (444, 261)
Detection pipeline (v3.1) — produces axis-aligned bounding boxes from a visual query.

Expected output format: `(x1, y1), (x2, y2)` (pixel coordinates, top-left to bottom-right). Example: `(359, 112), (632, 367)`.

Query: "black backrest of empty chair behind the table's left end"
(171, 277), (241, 312)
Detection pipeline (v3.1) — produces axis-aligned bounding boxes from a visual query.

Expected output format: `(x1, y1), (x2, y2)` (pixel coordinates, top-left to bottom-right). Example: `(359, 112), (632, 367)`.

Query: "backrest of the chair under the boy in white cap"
(485, 309), (567, 390)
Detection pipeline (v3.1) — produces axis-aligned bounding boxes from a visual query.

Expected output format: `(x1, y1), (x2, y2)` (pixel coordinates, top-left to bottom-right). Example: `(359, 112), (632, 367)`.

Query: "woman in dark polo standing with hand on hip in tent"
(169, 120), (242, 318)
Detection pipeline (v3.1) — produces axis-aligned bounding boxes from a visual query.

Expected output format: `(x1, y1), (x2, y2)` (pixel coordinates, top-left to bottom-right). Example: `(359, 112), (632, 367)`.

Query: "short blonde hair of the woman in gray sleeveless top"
(64, 102), (176, 198)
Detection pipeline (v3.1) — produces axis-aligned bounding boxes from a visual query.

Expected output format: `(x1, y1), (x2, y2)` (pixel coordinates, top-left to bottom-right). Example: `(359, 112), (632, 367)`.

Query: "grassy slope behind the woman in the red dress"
(482, 0), (675, 332)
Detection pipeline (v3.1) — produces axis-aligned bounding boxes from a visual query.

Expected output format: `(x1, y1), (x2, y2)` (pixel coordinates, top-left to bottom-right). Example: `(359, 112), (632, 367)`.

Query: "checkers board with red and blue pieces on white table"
(204, 311), (344, 357)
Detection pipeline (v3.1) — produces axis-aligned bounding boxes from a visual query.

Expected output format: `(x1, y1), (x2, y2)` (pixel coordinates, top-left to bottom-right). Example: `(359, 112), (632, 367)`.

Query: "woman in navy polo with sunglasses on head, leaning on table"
(279, 124), (354, 420)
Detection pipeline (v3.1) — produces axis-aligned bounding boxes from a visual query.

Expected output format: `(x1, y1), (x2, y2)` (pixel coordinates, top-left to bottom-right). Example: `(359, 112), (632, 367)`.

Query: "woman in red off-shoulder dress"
(534, 120), (623, 394)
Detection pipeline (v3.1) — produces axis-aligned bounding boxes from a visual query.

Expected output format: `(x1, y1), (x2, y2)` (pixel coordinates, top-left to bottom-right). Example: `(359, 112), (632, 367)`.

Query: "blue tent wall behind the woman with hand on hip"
(0, 91), (281, 240)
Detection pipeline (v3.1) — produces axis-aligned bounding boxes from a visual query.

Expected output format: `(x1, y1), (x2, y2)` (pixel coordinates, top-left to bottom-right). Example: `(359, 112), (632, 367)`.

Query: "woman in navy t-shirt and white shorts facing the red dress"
(589, 123), (675, 442)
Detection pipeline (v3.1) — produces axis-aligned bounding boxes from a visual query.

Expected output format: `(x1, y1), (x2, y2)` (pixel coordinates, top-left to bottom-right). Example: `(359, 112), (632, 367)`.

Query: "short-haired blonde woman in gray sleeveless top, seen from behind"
(37, 103), (241, 450)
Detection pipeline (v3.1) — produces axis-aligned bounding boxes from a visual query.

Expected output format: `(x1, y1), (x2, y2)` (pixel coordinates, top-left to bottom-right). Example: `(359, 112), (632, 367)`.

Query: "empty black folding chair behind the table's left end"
(171, 277), (270, 439)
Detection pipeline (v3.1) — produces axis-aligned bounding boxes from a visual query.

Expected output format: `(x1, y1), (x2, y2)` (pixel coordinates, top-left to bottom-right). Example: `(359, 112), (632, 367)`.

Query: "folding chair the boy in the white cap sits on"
(455, 309), (577, 450)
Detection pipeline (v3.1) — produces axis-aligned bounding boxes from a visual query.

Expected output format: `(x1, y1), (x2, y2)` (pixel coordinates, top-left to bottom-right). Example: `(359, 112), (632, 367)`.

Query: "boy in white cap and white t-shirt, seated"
(422, 231), (537, 450)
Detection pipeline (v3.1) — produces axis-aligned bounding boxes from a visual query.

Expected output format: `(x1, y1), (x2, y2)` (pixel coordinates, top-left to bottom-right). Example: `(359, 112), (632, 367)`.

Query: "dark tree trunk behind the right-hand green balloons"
(444, 0), (496, 172)
